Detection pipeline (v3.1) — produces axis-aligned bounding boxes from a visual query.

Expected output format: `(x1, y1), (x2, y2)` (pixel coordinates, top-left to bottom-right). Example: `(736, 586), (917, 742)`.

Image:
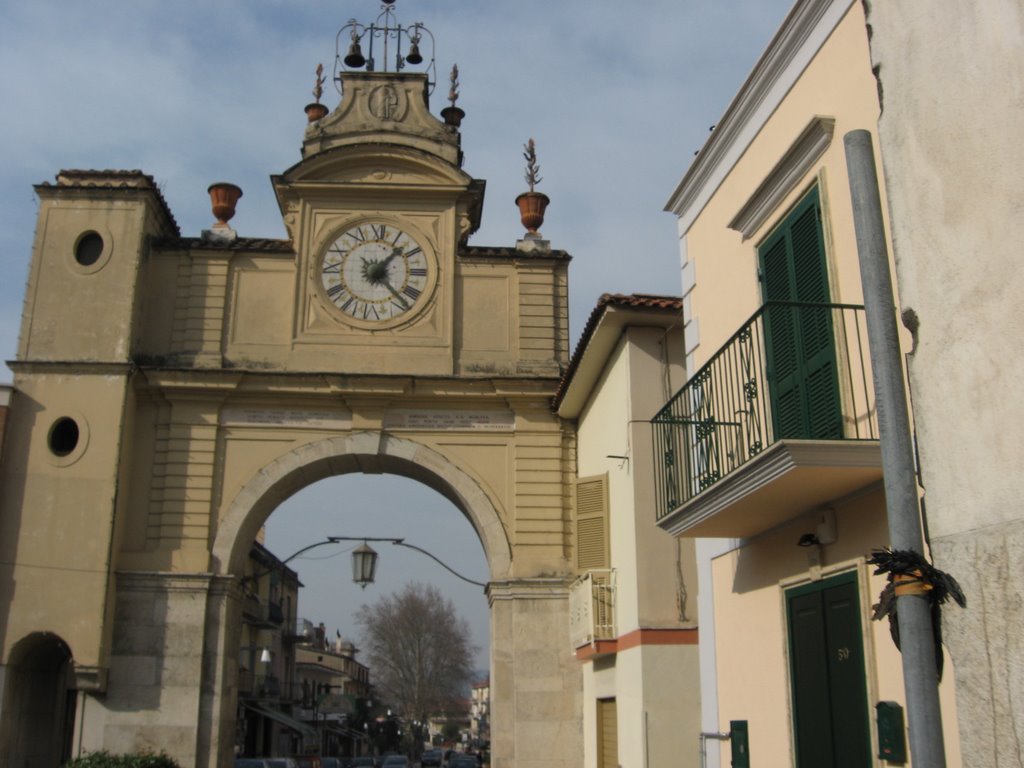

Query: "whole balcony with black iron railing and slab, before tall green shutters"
(651, 302), (882, 538)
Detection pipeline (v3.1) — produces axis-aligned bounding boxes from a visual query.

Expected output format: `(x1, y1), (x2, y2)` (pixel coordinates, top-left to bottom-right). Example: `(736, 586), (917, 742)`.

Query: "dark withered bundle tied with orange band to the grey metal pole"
(867, 548), (967, 680)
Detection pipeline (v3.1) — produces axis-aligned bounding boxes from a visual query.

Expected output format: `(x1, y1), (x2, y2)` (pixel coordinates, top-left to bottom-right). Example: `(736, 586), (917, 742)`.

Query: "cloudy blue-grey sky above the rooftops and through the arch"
(0, 0), (792, 668)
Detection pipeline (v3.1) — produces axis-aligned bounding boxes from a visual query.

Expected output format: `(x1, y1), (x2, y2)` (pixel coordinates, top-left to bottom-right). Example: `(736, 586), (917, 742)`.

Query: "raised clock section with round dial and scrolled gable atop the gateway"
(273, 66), (491, 376)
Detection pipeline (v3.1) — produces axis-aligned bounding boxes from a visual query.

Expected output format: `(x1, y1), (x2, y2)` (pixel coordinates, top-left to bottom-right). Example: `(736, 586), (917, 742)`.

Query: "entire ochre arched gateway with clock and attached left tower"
(0, 25), (582, 768)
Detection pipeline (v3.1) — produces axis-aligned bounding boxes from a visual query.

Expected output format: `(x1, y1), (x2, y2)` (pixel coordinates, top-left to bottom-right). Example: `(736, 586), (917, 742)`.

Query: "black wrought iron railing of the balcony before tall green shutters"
(651, 302), (878, 520)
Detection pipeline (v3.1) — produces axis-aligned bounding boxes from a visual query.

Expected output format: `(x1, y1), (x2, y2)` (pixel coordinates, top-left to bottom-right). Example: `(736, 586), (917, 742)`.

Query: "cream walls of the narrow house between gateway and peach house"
(577, 321), (700, 768)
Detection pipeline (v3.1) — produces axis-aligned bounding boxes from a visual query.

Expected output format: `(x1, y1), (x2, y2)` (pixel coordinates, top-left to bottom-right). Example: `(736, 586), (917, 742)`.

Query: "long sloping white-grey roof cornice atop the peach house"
(665, 0), (853, 233)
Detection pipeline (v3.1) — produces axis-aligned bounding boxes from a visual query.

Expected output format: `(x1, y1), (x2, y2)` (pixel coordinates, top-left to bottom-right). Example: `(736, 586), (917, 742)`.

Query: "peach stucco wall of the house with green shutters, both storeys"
(677, 2), (961, 766)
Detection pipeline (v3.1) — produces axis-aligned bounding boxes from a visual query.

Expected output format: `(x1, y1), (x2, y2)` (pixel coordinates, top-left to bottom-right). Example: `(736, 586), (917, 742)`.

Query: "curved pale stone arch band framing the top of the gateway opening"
(212, 432), (512, 581)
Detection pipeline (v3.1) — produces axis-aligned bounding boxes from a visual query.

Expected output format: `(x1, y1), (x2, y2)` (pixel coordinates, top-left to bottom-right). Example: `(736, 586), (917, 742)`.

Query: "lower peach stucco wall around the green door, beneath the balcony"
(712, 488), (961, 768)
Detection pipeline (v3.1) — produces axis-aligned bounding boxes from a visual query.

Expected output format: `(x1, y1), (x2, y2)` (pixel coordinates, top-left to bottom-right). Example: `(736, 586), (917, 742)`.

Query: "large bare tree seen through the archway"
(356, 582), (476, 720)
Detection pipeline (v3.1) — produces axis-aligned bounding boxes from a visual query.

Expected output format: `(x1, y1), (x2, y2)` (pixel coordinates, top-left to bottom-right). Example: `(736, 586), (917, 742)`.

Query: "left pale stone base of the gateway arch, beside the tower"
(68, 572), (234, 768)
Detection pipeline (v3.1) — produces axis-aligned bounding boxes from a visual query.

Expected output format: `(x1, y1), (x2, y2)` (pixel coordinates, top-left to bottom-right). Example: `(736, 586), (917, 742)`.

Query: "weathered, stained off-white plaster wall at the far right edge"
(869, 0), (1024, 768)
